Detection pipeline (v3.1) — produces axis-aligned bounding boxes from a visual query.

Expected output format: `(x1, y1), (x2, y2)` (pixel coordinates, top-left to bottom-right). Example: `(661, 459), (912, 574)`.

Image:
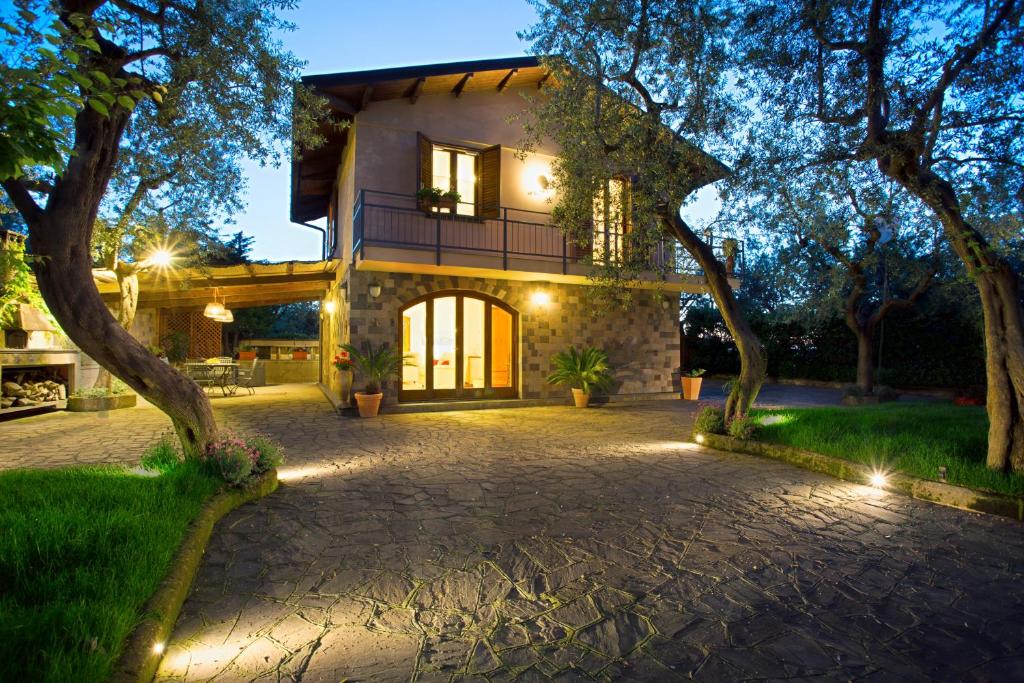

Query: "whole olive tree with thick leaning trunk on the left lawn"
(0, 0), (323, 455)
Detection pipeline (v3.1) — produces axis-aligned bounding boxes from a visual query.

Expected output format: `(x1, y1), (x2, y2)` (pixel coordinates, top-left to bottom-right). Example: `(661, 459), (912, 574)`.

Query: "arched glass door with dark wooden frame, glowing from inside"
(398, 292), (518, 400)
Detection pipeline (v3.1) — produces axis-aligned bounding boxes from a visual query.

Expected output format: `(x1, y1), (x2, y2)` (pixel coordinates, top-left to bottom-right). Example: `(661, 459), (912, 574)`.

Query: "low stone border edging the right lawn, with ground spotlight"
(693, 433), (1024, 521)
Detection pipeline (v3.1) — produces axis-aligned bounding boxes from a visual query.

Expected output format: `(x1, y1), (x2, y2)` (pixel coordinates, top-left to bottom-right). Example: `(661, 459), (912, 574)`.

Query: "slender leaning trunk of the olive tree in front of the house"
(662, 209), (768, 420)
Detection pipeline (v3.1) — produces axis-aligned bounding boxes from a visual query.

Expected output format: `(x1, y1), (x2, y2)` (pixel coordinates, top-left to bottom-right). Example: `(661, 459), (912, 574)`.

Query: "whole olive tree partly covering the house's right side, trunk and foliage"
(522, 0), (766, 418)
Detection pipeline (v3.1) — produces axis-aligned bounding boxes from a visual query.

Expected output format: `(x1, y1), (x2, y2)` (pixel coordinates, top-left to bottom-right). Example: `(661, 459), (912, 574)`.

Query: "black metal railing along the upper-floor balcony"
(352, 189), (743, 274)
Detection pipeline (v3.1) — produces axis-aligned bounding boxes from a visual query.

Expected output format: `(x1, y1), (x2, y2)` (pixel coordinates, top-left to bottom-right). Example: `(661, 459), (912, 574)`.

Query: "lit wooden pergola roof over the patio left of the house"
(93, 260), (341, 310)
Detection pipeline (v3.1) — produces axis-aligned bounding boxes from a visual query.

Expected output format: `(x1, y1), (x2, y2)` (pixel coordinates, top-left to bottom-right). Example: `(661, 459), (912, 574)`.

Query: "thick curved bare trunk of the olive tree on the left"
(4, 100), (217, 456)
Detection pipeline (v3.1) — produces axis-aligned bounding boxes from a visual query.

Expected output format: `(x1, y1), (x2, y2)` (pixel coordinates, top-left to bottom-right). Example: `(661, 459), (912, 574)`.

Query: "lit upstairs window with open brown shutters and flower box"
(417, 133), (502, 218)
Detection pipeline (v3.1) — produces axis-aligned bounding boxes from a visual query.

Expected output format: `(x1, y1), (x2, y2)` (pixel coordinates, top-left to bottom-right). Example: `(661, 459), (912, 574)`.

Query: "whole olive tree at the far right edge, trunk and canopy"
(734, 0), (1024, 471)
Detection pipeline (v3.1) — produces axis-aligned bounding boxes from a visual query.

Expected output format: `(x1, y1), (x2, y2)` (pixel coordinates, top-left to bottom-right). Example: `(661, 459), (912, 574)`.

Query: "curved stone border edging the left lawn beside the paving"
(111, 470), (278, 683)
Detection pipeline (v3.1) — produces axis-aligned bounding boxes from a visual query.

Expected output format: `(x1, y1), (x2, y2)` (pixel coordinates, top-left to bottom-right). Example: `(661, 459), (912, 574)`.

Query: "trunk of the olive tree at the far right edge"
(879, 159), (1024, 472)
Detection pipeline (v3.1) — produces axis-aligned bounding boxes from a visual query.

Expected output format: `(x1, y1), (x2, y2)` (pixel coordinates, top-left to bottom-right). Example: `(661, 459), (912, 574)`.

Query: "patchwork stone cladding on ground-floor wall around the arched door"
(346, 270), (679, 402)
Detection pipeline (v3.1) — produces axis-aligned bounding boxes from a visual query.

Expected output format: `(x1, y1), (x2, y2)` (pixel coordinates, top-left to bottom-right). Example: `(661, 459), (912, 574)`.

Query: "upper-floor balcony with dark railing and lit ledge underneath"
(352, 189), (743, 291)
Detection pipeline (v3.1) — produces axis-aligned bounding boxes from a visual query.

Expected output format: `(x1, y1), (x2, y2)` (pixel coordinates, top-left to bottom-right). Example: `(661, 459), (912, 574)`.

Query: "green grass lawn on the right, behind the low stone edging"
(752, 403), (1024, 496)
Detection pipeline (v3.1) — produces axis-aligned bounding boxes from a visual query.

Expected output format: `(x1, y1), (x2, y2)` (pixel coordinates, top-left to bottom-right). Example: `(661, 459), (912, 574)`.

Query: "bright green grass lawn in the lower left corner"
(0, 463), (220, 682)
